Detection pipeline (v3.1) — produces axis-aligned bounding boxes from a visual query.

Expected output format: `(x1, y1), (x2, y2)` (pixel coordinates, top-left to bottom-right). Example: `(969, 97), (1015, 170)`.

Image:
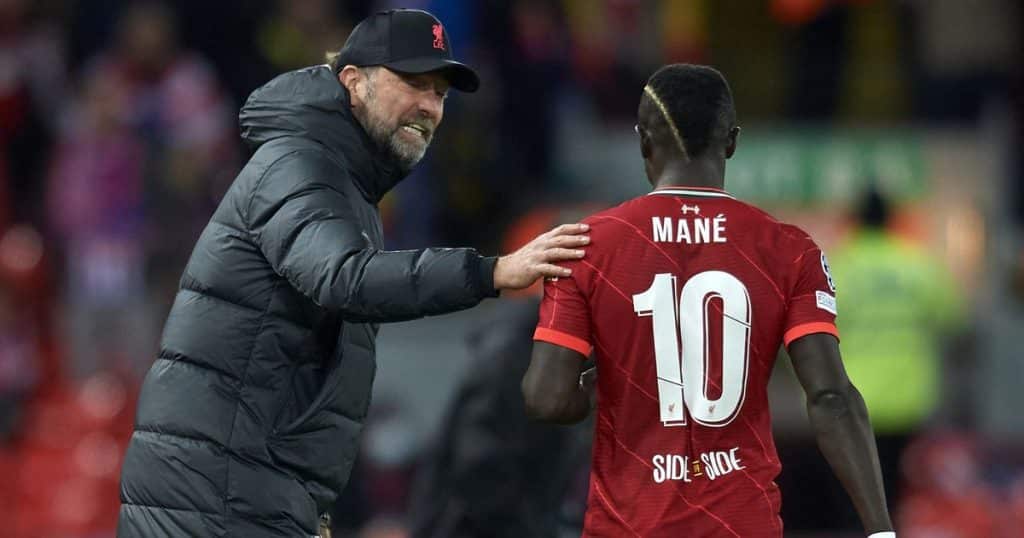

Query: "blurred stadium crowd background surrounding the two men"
(0, 0), (1024, 538)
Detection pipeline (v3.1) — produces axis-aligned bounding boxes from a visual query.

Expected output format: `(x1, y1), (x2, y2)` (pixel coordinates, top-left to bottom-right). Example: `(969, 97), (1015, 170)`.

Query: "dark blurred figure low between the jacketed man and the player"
(410, 298), (589, 538)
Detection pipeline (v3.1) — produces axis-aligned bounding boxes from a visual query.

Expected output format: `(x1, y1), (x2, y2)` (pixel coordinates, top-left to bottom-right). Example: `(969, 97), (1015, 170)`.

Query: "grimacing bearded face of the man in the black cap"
(353, 68), (449, 171)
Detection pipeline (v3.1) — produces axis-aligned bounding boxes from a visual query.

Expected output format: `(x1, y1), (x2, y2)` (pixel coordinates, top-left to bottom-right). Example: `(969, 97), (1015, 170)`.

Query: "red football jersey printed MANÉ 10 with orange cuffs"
(535, 188), (838, 538)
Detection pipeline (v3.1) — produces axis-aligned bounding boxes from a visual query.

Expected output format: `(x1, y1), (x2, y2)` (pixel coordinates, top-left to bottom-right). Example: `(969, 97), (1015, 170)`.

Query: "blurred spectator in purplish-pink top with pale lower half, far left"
(48, 69), (155, 377)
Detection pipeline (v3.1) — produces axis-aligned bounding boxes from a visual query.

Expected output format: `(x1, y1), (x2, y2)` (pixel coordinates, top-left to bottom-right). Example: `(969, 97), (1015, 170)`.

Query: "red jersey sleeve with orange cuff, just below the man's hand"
(534, 277), (594, 357)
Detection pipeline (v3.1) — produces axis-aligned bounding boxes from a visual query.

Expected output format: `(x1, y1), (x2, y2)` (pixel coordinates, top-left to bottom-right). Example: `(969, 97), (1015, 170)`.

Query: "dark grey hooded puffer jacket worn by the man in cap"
(118, 66), (496, 538)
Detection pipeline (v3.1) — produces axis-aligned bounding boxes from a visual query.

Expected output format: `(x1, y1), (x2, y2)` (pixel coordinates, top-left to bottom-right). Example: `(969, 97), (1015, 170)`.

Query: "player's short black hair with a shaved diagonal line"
(644, 64), (736, 158)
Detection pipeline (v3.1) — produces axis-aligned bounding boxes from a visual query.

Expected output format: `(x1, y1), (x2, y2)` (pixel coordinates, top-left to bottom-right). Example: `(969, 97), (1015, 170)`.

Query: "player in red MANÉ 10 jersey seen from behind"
(522, 65), (894, 538)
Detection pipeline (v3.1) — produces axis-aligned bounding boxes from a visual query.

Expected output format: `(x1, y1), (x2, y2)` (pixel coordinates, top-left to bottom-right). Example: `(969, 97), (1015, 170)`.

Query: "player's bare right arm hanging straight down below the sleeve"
(788, 333), (893, 534)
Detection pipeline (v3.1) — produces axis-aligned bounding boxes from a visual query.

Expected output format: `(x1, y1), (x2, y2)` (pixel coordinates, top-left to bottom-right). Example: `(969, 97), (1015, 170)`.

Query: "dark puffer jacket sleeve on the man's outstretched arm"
(246, 153), (497, 322)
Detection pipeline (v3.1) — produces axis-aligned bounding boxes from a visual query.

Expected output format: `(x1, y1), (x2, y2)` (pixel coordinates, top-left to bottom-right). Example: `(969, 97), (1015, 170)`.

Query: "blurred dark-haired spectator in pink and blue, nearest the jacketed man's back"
(81, 1), (238, 301)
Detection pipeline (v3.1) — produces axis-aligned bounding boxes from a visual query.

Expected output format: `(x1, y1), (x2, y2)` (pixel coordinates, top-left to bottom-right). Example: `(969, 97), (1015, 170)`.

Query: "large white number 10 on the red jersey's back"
(633, 271), (751, 427)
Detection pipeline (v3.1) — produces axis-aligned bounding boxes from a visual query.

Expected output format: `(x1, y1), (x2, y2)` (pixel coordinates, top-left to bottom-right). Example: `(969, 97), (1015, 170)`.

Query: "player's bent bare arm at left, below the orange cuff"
(522, 341), (594, 424)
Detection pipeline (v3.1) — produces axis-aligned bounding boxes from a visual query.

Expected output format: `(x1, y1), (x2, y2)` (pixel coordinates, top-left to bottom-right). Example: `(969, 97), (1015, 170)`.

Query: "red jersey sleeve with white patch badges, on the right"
(782, 243), (839, 346)
